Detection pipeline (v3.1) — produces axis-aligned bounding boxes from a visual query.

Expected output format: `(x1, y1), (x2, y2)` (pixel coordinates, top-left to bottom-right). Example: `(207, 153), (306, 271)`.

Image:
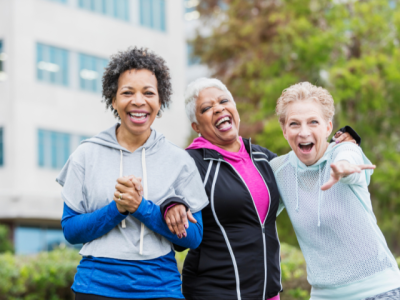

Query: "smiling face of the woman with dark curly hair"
(112, 69), (161, 136)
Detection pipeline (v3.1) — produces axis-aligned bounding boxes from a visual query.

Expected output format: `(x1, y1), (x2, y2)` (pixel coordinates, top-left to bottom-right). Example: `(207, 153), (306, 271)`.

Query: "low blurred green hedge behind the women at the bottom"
(0, 244), (400, 300)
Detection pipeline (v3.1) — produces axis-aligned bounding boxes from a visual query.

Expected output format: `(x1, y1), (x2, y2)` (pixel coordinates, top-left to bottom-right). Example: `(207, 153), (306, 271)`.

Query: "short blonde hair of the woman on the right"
(275, 82), (335, 126)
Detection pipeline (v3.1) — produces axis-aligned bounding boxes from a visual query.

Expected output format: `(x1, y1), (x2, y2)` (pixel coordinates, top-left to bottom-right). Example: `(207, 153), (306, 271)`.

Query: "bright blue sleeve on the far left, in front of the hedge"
(61, 201), (127, 244)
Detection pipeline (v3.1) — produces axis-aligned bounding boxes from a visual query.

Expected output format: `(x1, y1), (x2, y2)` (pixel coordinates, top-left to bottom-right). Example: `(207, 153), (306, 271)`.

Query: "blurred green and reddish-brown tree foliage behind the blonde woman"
(193, 0), (400, 254)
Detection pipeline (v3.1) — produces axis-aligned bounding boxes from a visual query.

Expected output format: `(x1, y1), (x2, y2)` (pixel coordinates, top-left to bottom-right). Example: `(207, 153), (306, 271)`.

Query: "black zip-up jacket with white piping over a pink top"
(182, 139), (282, 300)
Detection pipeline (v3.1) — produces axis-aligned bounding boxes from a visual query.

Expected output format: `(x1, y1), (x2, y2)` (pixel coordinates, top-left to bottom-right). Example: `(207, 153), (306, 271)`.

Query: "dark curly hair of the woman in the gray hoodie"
(103, 47), (172, 118)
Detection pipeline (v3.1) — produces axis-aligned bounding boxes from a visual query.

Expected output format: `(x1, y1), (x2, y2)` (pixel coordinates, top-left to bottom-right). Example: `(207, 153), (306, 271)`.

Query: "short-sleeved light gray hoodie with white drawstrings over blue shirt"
(56, 124), (208, 260)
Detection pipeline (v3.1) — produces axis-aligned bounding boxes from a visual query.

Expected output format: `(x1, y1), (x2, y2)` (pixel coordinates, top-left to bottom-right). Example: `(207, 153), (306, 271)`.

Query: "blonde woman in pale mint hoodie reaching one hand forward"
(271, 82), (400, 300)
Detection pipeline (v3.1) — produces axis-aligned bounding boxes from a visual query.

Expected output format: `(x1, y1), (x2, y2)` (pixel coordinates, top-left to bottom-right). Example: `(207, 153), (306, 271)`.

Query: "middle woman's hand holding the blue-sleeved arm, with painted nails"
(165, 204), (197, 239)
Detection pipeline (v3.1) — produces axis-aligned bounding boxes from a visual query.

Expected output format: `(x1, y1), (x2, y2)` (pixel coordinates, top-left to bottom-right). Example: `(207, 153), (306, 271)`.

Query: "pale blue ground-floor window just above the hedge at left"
(15, 226), (82, 254)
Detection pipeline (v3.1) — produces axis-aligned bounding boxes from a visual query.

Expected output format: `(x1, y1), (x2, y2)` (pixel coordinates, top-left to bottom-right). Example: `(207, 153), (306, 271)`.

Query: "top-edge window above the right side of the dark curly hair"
(140, 0), (166, 31)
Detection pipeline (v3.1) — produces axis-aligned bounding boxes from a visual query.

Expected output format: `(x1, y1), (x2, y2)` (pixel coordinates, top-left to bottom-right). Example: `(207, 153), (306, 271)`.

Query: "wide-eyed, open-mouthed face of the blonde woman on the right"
(283, 100), (332, 166)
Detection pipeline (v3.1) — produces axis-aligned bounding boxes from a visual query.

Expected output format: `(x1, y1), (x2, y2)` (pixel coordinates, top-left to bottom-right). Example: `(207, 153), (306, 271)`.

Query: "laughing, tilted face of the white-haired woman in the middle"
(192, 87), (239, 146)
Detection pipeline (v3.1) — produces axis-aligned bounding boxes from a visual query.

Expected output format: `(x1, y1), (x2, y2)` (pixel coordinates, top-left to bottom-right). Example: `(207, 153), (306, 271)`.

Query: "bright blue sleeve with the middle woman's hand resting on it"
(132, 198), (203, 249)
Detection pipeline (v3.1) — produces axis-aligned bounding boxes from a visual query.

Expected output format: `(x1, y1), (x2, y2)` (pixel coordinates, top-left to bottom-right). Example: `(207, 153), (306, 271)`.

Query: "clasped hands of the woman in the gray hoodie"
(113, 176), (143, 213)
